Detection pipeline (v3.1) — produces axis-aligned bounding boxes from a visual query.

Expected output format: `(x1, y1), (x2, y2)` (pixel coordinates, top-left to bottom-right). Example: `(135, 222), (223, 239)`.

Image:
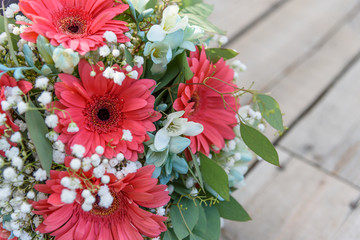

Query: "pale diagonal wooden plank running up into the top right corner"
(230, 0), (359, 92)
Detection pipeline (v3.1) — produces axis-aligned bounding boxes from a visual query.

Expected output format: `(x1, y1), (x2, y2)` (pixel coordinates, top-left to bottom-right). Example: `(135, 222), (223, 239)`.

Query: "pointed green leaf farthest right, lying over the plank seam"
(240, 122), (280, 166)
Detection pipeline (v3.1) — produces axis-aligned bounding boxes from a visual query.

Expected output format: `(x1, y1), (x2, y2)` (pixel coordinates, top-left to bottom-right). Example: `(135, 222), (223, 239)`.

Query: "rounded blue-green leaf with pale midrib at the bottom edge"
(170, 198), (199, 239)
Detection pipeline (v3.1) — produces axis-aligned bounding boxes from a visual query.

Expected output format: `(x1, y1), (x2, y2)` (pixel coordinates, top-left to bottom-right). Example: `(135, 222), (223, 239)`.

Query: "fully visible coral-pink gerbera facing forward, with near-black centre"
(51, 60), (161, 161)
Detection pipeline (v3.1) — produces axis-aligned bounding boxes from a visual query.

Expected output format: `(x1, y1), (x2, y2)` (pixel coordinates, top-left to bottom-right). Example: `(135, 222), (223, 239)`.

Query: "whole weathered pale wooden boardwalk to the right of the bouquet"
(207, 0), (360, 240)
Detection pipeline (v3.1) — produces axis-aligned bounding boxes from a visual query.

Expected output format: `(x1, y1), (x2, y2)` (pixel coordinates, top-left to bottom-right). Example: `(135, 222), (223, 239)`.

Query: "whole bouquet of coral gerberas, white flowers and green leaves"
(0, 0), (284, 240)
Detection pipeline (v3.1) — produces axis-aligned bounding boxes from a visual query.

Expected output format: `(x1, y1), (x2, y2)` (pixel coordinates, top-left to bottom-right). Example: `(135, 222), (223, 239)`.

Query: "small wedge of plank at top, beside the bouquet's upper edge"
(205, 0), (288, 38)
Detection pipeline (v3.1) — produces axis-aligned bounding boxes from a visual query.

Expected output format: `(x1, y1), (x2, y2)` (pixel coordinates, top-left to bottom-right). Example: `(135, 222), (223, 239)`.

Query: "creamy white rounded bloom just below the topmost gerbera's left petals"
(52, 47), (80, 74)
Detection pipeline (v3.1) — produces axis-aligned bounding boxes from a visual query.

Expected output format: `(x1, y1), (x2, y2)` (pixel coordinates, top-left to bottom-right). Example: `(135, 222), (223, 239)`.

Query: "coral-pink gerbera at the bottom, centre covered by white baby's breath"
(32, 165), (170, 240)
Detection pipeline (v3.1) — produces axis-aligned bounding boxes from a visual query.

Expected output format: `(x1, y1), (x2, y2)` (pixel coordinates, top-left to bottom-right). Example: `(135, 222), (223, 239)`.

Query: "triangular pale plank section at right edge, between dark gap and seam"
(280, 56), (360, 186)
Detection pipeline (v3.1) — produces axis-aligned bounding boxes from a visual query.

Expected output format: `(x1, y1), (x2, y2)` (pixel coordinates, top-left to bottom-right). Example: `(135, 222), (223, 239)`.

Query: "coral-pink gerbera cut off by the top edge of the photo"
(18, 0), (129, 55)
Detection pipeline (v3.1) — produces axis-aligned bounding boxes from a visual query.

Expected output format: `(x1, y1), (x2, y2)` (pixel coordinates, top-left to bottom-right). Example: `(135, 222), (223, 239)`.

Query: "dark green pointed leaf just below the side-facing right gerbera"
(200, 153), (230, 200)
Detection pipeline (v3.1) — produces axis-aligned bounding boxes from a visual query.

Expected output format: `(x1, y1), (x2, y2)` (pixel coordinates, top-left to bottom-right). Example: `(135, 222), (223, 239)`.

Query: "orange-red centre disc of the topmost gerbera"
(53, 7), (91, 38)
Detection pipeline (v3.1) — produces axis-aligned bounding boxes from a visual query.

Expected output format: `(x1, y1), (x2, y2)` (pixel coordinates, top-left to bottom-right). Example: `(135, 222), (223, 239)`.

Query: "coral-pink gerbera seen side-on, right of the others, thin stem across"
(174, 49), (240, 155)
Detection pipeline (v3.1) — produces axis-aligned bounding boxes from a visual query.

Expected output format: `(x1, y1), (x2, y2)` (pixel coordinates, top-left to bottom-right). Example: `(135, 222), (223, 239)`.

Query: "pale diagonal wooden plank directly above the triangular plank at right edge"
(264, 11), (360, 139)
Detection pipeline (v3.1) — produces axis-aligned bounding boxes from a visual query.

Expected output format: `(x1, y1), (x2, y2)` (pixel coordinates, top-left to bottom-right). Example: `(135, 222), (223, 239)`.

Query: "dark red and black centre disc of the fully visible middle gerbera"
(83, 94), (124, 134)
